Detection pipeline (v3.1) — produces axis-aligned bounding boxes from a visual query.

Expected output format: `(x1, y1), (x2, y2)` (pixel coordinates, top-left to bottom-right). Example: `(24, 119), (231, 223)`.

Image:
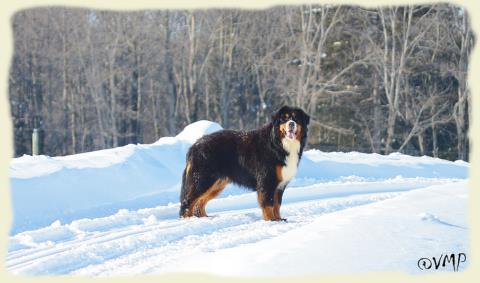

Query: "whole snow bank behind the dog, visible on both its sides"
(10, 121), (469, 234)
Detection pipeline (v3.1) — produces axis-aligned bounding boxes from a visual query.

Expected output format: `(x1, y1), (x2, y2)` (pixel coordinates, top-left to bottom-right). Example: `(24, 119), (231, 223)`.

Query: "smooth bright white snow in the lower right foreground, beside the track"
(166, 184), (468, 276)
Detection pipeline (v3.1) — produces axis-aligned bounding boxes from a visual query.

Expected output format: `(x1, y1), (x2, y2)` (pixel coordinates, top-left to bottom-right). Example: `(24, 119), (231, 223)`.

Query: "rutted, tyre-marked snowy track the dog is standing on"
(6, 178), (462, 276)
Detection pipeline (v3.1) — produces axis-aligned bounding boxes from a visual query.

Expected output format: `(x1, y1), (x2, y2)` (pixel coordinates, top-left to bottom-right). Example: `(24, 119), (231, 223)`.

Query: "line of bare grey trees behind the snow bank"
(9, 4), (474, 160)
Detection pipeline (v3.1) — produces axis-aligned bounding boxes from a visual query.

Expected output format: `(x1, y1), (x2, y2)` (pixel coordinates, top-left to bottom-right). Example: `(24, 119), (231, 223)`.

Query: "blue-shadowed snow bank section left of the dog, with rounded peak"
(10, 121), (221, 233)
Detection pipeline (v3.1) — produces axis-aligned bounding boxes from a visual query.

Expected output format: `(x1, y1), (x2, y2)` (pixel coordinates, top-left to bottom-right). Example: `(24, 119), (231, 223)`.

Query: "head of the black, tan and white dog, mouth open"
(272, 106), (310, 144)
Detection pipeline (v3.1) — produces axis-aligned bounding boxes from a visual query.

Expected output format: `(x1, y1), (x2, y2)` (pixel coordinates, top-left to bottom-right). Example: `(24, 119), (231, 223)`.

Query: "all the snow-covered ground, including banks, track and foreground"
(6, 121), (469, 276)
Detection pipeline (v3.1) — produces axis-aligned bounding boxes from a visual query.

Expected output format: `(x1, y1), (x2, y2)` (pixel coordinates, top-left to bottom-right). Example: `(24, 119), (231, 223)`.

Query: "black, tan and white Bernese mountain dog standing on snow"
(180, 106), (310, 221)
